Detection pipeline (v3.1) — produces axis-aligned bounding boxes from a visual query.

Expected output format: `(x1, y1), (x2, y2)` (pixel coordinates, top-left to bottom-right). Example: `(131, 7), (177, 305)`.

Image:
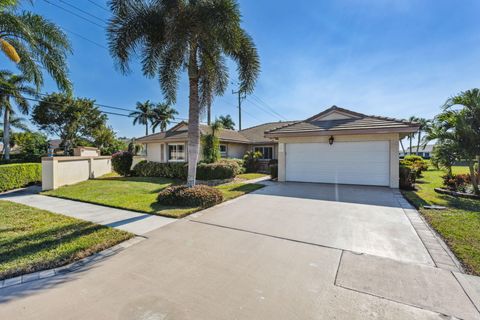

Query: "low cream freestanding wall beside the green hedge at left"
(42, 156), (112, 190)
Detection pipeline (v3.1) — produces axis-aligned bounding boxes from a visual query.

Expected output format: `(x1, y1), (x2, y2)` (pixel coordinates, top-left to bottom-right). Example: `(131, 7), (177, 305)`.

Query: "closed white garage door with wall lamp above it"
(286, 141), (390, 186)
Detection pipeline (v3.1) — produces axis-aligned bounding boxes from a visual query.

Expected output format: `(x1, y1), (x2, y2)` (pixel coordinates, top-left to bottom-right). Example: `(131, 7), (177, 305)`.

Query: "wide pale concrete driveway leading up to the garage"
(0, 184), (480, 320)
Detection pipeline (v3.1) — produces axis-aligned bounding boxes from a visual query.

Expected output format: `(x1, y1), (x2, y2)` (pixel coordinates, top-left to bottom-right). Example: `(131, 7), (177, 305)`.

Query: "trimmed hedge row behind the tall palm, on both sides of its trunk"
(133, 160), (238, 180)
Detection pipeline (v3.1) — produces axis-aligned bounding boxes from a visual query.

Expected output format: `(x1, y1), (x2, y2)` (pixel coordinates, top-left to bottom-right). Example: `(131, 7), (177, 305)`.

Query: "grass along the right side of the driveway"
(403, 167), (480, 275)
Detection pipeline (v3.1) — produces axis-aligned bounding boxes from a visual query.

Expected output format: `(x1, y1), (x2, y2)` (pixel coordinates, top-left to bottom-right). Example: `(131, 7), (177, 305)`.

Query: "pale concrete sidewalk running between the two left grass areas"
(0, 186), (176, 235)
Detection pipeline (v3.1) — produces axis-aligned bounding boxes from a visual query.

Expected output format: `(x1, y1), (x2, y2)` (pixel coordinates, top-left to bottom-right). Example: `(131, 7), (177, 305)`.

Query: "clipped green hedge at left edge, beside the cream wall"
(0, 163), (42, 192)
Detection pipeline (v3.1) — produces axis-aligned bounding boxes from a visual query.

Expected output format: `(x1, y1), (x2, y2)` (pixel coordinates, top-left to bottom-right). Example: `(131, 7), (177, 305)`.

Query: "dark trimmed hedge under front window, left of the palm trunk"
(133, 160), (187, 180)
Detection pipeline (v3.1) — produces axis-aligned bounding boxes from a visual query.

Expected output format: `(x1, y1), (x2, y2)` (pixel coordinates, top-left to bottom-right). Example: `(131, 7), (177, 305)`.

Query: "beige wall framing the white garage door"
(278, 133), (399, 188)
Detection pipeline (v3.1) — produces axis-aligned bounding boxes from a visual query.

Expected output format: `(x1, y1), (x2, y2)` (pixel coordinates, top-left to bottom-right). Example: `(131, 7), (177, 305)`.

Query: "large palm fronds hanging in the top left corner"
(0, 0), (72, 93)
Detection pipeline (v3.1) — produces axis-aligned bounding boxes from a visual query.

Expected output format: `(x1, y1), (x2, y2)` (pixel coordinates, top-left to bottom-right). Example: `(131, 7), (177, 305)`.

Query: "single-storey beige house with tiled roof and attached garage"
(137, 106), (419, 188)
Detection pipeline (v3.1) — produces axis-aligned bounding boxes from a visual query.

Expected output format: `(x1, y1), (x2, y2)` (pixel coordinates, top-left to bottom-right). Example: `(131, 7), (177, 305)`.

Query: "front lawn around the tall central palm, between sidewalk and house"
(43, 176), (263, 218)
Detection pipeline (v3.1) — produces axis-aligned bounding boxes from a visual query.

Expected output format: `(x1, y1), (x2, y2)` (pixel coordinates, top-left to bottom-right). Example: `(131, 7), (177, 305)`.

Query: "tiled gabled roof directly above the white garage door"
(265, 106), (419, 138)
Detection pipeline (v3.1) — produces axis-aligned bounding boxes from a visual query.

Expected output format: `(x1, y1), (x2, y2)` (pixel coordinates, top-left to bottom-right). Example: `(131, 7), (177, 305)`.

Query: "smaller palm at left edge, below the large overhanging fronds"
(0, 70), (36, 160)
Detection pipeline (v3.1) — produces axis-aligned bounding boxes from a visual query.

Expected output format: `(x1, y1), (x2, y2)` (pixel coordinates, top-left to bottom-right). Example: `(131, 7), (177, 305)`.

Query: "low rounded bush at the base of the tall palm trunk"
(157, 185), (223, 208)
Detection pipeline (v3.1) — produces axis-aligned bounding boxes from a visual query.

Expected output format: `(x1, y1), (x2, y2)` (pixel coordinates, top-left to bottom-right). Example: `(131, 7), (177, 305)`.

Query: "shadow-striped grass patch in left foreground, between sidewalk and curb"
(0, 201), (133, 279)
